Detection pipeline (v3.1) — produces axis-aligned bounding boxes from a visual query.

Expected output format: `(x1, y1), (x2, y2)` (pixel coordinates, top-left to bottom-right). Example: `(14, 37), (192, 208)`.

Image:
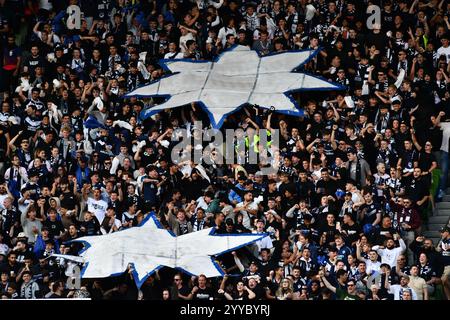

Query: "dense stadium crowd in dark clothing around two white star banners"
(0, 0), (450, 300)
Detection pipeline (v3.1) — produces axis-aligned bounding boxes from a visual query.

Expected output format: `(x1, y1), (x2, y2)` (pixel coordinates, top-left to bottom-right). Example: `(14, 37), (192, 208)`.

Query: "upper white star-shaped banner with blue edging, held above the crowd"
(126, 45), (345, 128)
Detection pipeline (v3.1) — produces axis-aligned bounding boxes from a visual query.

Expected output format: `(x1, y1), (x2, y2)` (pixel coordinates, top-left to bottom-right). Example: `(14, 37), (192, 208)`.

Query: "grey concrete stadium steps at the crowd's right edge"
(423, 188), (450, 245)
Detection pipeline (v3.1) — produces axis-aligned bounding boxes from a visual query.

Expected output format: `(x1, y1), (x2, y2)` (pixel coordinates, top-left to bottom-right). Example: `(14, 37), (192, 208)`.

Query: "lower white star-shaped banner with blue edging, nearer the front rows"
(58, 213), (267, 288)
